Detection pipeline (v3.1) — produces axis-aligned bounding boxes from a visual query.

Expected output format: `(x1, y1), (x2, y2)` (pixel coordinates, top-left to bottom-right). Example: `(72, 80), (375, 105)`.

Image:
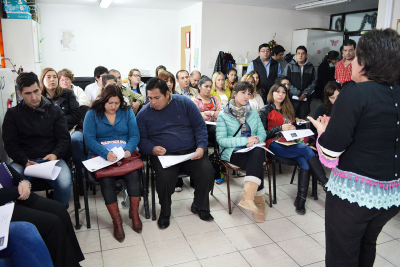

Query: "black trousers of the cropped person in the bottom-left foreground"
(11, 193), (85, 267)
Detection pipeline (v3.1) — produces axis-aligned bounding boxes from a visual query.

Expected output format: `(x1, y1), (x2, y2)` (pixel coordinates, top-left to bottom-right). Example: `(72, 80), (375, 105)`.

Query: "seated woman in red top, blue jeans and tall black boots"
(260, 84), (328, 215)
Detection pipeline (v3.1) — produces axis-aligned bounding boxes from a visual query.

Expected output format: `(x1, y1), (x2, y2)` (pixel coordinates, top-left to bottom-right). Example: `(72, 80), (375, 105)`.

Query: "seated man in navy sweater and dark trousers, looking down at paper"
(137, 78), (214, 229)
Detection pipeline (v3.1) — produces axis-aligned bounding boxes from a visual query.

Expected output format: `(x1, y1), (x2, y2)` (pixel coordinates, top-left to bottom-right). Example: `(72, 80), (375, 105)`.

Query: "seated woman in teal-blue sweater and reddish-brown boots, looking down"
(83, 85), (142, 242)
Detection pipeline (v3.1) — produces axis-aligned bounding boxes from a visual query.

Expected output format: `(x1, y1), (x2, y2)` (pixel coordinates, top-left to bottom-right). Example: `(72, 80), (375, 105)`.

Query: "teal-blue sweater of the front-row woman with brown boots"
(83, 109), (140, 159)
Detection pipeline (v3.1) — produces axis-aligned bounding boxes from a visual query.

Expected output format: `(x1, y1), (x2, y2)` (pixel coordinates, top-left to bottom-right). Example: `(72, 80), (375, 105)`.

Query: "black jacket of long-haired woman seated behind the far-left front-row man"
(48, 89), (82, 131)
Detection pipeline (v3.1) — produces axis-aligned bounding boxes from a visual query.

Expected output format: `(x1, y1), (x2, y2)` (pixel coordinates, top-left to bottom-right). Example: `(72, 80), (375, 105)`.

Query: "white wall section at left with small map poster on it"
(38, 4), (180, 78)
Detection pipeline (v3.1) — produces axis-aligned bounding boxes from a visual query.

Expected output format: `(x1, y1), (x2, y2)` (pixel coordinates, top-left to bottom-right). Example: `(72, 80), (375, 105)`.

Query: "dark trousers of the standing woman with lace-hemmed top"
(325, 191), (400, 267)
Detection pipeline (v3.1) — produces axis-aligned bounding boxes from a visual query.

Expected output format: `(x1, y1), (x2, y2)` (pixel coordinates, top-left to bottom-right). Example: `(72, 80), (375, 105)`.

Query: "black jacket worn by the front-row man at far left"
(2, 96), (71, 166)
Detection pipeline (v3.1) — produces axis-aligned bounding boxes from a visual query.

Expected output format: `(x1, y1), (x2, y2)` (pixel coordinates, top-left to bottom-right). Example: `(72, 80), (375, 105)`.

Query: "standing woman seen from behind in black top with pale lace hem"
(309, 29), (400, 267)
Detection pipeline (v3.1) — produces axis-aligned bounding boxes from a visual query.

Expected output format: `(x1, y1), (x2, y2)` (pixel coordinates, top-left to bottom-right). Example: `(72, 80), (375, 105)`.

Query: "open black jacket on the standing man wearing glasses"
(253, 57), (279, 103)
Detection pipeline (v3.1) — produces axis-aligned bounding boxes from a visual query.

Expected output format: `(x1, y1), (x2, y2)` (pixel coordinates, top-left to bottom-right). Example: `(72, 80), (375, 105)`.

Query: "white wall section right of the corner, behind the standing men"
(201, 2), (330, 76)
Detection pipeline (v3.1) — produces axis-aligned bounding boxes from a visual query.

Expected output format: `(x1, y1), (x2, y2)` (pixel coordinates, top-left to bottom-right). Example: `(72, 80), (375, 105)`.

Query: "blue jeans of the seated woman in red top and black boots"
(269, 142), (315, 170)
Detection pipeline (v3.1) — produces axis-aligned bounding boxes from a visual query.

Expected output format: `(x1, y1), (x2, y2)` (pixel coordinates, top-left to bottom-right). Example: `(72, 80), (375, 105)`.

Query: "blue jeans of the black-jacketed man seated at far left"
(10, 159), (71, 206)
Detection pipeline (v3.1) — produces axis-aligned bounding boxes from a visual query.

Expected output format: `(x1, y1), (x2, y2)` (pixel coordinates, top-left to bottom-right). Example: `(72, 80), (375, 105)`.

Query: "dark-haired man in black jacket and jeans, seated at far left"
(2, 72), (71, 205)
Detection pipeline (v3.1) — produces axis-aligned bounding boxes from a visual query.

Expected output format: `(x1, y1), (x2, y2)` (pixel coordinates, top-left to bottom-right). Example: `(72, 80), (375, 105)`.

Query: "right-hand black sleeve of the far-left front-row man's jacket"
(51, 106), (71, 159)
